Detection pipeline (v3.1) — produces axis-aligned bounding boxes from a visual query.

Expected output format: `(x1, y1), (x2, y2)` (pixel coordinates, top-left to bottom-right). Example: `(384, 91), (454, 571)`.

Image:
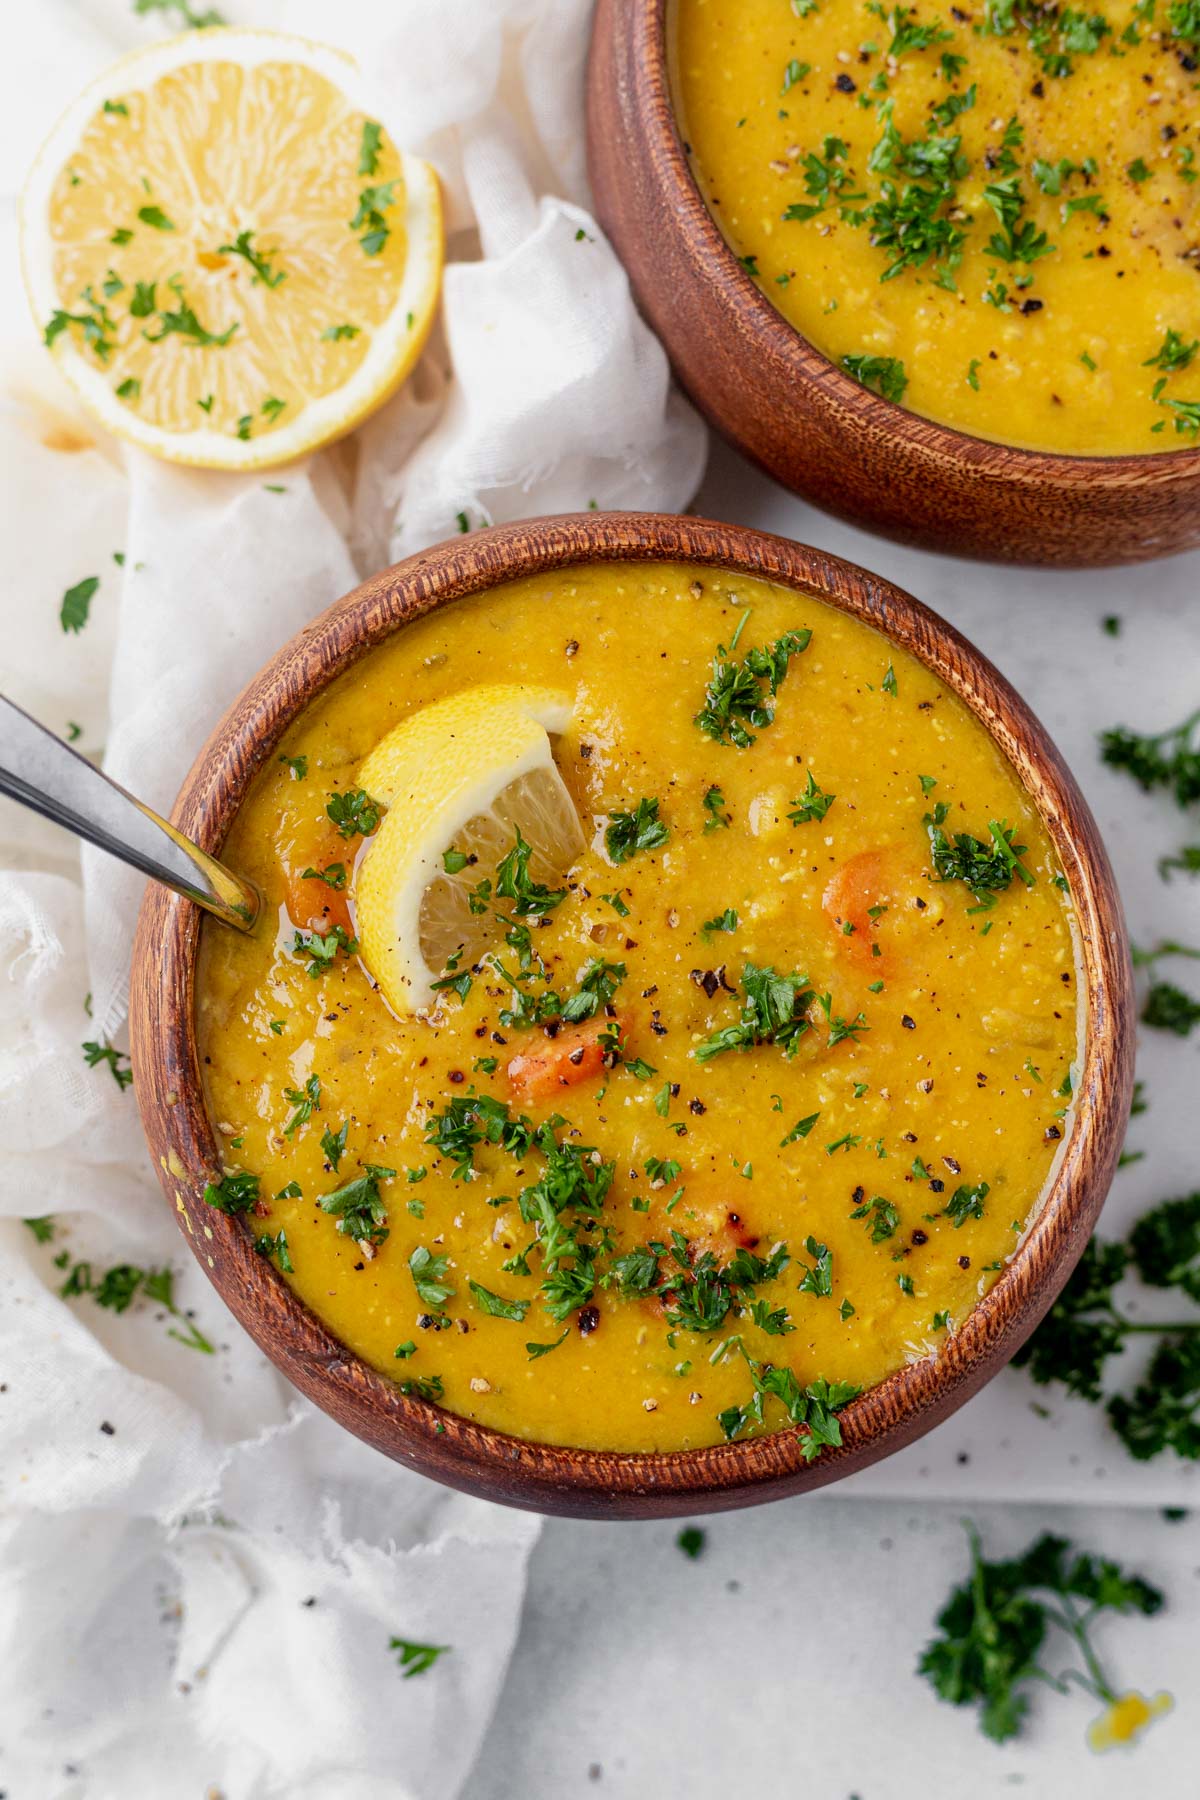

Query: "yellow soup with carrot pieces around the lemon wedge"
(198, 563), (1079, 1453)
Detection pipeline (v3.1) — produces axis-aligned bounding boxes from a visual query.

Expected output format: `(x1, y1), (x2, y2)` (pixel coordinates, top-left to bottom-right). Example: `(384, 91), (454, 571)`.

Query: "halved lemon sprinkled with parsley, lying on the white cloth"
(22, 31), (443, 468)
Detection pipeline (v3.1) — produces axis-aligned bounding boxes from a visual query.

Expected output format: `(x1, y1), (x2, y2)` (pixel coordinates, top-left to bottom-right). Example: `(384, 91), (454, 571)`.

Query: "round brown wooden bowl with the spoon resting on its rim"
(131, 513), (1133, 1517)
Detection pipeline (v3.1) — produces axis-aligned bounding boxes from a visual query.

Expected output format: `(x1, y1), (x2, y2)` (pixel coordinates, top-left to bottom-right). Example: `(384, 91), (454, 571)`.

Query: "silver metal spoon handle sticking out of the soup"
(0, 695), (263, 931)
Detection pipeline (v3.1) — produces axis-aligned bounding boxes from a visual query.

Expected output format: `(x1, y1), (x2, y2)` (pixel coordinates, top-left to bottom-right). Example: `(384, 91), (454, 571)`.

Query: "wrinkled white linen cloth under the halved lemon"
(0, 0), (705, 1800)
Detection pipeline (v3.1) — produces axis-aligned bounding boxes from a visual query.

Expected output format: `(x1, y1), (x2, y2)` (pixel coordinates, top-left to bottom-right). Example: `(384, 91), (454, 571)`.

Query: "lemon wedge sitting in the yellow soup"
(354, 686), (583, 1013)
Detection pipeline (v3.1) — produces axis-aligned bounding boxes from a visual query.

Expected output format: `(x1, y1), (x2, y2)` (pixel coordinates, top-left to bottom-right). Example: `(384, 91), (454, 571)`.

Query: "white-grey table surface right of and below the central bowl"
(466, 445), (1200, 1800)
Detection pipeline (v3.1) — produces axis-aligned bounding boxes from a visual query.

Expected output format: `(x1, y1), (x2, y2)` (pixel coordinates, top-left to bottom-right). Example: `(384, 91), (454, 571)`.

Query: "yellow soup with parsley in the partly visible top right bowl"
(673, 0), (1200, 455)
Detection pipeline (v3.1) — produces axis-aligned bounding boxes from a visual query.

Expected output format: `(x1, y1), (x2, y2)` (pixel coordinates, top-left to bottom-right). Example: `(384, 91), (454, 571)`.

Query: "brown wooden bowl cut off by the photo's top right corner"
(588, 0), (1200, 567)
